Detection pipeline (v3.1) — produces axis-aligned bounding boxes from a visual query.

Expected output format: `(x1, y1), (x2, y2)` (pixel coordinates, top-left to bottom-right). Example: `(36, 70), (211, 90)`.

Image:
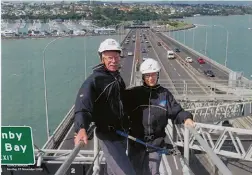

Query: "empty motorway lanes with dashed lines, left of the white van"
(149, 30), (206, 95)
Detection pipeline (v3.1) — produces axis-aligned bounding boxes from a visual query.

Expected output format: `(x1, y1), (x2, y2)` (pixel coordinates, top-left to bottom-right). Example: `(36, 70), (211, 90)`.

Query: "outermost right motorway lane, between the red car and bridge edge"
(157, 33), (229, 80)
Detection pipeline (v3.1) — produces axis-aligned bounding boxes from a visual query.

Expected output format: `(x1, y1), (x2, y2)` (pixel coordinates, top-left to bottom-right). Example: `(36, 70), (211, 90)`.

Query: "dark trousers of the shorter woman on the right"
(129, 147), (161, 175)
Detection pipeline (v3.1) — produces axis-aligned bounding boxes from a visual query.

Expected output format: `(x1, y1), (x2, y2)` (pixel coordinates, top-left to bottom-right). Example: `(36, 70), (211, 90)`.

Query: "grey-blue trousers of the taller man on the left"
(99, 140), (136, 175)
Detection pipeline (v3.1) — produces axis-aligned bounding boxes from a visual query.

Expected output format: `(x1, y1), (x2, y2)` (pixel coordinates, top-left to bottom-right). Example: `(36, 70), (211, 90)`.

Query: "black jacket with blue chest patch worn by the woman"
(124, 85), (192, 150)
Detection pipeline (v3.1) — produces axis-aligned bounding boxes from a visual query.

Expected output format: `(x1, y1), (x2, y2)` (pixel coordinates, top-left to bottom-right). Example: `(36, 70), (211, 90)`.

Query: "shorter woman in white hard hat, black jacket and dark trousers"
(125, 58), (194, 175)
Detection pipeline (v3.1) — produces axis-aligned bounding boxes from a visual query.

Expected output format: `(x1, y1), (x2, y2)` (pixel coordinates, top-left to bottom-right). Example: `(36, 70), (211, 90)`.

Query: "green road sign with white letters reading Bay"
(1, 126), (35, 165)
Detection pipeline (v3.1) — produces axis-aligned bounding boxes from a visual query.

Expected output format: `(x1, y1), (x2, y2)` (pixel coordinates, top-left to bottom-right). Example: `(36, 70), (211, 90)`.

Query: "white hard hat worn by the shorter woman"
(140, 58), (161, 74)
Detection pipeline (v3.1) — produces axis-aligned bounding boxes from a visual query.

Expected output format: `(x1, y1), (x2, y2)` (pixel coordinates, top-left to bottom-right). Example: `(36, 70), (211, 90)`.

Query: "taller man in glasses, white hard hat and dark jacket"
(75, 39), (135, 175)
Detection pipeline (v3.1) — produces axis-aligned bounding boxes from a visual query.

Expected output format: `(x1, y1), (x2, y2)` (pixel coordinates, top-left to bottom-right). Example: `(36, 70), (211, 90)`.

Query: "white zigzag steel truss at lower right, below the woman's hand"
(166, 122), (252, 161)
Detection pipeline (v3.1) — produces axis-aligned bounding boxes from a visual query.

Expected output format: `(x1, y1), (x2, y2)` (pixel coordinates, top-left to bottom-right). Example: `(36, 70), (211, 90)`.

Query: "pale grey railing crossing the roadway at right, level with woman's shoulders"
(130, 79), (252, 100)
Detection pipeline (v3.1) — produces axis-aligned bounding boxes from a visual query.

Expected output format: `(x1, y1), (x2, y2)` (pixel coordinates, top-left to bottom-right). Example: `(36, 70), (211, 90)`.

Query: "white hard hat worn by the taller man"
(98, 38), (122, 53)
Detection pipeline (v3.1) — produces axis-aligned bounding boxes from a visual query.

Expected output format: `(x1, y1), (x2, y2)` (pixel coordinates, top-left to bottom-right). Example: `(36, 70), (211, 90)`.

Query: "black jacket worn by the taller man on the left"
(75, 64), (125, 139)
